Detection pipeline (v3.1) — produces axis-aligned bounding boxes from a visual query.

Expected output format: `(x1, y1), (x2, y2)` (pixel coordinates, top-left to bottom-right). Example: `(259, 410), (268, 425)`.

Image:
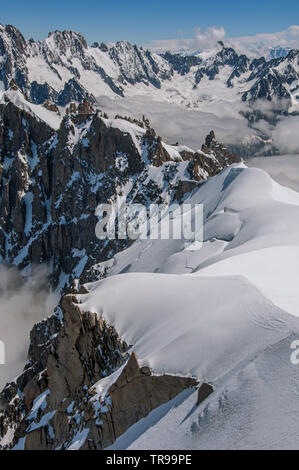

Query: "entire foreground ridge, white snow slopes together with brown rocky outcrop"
(0, 163), (299, 449)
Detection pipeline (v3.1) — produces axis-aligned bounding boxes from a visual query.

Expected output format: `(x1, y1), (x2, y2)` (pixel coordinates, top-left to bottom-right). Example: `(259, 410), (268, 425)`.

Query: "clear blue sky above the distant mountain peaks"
(0, 0), (299, 44)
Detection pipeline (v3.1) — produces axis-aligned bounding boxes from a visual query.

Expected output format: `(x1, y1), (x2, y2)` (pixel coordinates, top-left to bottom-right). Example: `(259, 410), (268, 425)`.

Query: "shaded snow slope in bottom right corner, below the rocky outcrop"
(109, 333), (299, 450)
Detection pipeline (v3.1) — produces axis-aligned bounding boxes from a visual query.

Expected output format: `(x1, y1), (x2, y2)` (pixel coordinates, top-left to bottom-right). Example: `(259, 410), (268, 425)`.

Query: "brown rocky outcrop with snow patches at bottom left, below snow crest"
(0, 295), (197, 450)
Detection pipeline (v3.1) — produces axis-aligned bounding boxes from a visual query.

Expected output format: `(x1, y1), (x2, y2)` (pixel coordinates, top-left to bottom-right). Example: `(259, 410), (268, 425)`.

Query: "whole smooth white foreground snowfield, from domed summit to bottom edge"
(78, 165), (299, 449)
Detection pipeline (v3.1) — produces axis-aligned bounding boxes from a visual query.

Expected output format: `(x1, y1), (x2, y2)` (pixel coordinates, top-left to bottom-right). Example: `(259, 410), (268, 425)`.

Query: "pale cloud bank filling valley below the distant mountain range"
(98, 96), (299, 154)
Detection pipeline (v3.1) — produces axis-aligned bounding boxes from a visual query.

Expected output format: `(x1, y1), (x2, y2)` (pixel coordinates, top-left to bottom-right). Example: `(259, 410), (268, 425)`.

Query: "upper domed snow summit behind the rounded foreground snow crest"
(90, 163), (299, 316)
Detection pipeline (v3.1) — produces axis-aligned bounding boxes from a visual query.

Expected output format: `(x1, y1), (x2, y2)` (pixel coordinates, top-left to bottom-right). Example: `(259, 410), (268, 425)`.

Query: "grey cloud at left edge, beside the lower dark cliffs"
(0, 265), (58, 389)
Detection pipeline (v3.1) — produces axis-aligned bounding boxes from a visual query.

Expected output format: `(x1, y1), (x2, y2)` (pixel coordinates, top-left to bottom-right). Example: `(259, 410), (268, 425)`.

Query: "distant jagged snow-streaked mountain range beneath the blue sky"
(0, 25), (299, 120)
